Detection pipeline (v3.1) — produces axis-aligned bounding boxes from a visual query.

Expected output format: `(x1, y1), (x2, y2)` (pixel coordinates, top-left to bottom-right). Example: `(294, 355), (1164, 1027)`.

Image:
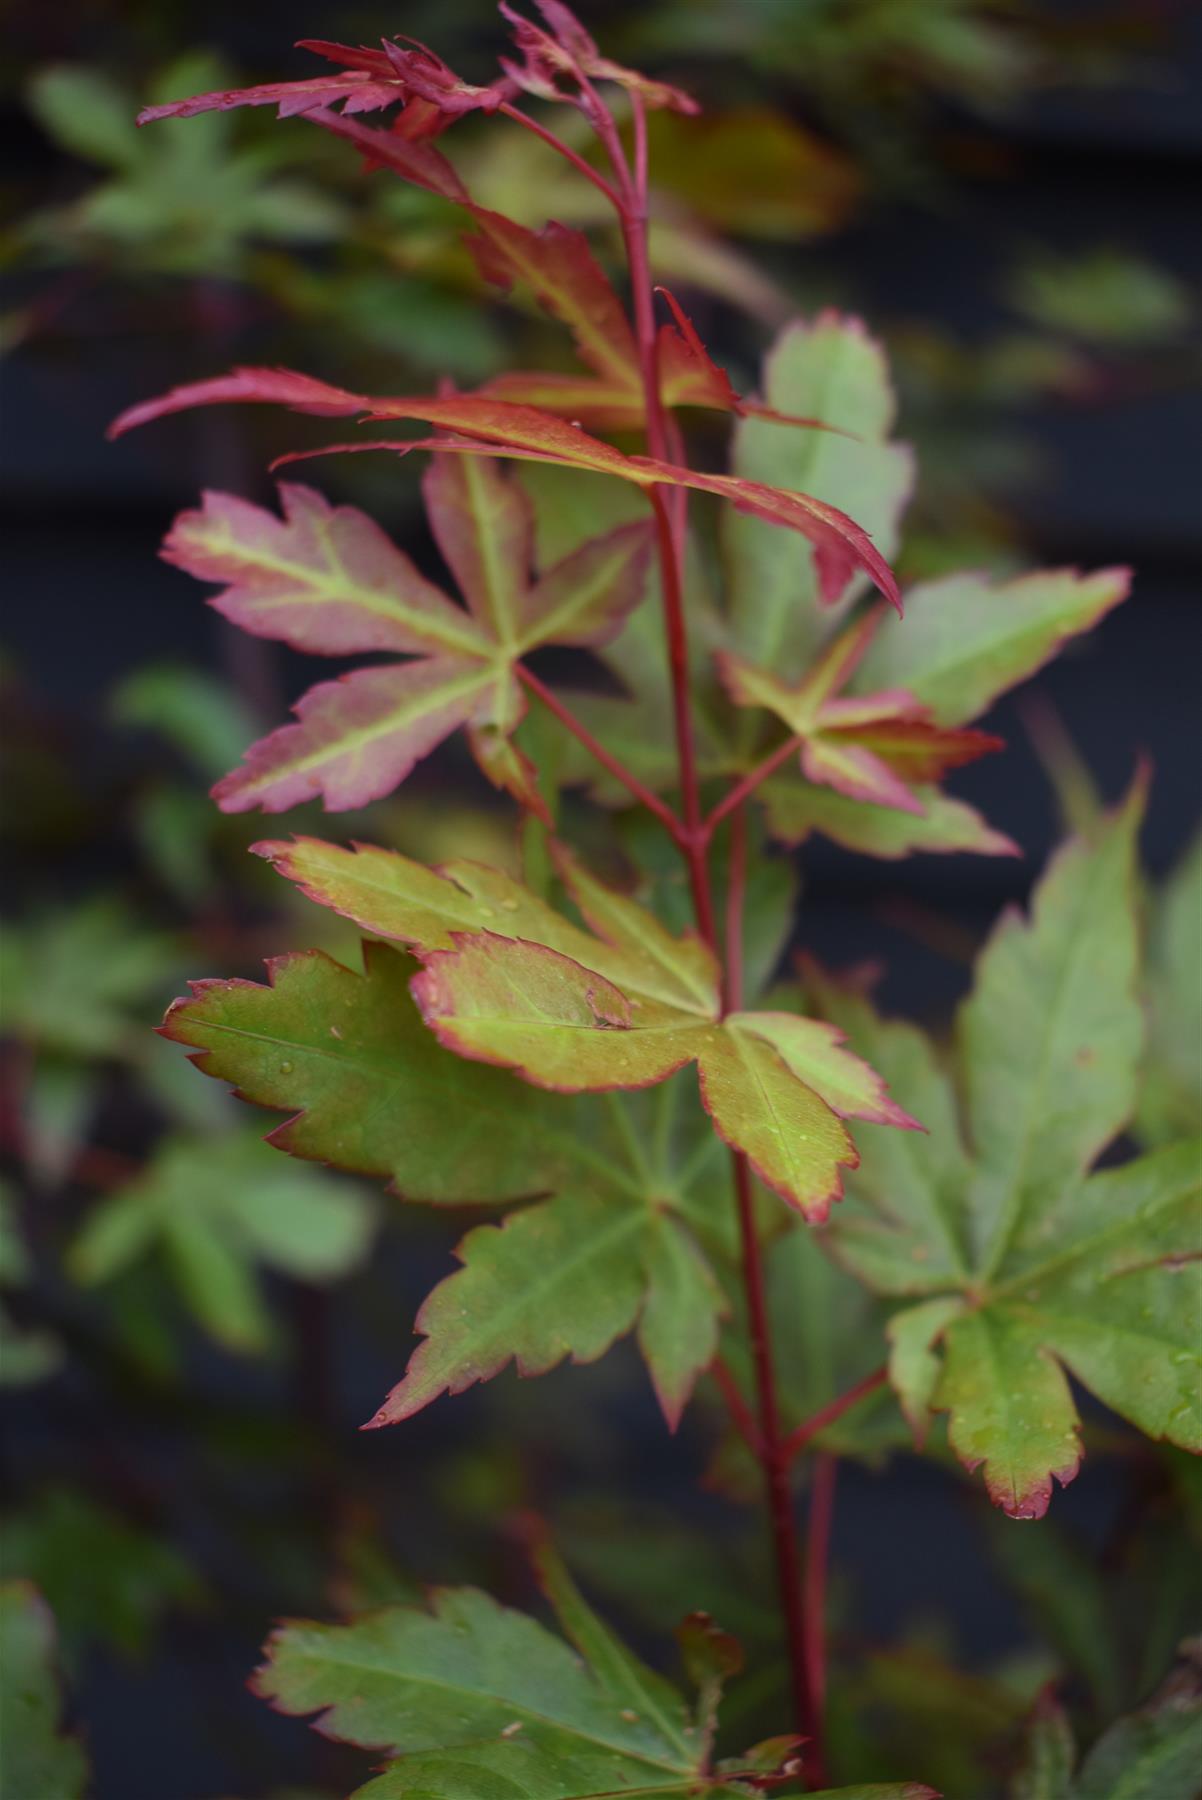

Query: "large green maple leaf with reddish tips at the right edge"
(815, 785), (1202, 1517)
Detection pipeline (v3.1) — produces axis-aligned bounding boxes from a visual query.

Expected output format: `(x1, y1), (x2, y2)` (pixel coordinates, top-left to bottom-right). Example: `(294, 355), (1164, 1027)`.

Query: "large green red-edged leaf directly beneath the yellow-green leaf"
(164, 943), (734, 1424)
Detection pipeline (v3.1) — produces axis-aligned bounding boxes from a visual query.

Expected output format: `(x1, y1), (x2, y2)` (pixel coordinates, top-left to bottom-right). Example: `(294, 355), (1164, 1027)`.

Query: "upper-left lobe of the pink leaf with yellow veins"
(162, 482), (489, 655)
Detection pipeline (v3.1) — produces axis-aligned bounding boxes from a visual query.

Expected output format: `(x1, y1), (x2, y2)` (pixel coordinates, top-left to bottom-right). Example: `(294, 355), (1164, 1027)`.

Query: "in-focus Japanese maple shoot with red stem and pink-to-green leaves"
(113, 0), (1200, 1800)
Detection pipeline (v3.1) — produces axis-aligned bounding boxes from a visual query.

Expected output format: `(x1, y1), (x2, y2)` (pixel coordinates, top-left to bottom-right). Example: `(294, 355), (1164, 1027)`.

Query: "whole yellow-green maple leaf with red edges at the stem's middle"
(248, 839), (914, 1219)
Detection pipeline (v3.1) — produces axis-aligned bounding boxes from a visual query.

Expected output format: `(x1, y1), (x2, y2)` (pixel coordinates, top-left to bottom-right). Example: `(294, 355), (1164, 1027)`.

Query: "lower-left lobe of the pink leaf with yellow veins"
(212, 657), (493, 812)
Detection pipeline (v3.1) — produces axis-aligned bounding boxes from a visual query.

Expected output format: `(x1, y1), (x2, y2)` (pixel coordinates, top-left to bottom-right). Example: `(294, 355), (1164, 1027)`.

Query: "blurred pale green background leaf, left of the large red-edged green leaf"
(68, 1136), (376, 1354)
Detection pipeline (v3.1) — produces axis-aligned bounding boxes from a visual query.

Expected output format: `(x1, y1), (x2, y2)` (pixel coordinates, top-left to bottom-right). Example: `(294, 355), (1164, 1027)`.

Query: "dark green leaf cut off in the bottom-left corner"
(0, 1580), (88, 1800)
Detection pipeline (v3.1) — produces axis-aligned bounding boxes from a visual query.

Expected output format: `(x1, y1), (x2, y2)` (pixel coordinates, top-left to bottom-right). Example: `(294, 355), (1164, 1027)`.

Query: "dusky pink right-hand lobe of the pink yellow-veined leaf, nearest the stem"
(522, 520), (655, 648)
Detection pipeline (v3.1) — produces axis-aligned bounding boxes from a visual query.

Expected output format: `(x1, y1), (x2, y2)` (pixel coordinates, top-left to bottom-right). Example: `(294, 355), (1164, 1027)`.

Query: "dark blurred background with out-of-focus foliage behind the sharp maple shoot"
(0, 0), (1202, 1800)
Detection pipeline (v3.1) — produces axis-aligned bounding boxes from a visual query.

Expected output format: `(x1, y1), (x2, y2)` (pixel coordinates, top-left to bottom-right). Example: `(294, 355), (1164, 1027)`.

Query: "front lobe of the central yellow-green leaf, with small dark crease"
(412, 932), (698, 1094)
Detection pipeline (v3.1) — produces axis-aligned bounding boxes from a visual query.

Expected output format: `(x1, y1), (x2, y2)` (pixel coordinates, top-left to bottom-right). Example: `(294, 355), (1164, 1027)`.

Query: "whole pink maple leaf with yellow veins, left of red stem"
(164, 457), (651, 812)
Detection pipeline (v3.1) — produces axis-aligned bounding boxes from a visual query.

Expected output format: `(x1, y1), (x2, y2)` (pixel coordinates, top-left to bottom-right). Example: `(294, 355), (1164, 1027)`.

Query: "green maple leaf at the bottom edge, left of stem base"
(254, 1544), (936, 1800)
